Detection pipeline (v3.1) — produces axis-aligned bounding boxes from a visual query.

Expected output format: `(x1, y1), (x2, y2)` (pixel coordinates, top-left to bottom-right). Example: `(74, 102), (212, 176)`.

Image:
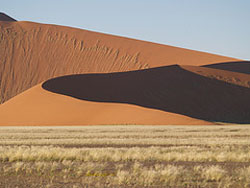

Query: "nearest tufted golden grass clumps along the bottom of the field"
(0, 161), (250, 187)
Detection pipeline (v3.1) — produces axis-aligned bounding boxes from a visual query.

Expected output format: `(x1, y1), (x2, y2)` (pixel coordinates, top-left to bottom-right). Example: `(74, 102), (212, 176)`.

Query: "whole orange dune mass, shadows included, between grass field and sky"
(0, 13), (250, 125)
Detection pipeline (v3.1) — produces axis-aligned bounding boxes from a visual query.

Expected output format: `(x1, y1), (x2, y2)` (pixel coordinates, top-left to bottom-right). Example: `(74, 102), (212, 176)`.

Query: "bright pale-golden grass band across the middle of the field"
(0, 146), (250, 162)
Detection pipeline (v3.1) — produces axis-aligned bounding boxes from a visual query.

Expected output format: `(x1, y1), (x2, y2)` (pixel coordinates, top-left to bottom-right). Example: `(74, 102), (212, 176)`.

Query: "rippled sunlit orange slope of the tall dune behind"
(0, 22), (237, 103)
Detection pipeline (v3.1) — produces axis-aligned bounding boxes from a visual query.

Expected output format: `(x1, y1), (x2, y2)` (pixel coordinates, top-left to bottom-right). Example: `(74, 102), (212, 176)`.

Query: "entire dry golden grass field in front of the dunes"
(0, 125), (250, 188)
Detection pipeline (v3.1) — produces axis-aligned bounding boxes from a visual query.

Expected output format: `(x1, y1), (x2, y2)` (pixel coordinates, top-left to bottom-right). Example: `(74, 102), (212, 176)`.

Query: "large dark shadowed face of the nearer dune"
(42, 65), (250, 123)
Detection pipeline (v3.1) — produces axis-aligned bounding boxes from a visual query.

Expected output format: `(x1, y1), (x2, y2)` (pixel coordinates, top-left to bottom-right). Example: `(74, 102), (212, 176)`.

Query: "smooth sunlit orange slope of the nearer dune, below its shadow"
(0, 85), (214, 126)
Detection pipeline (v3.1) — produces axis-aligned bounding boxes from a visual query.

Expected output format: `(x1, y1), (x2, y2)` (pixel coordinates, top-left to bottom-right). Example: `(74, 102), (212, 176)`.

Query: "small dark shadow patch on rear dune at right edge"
(203, 61), (250, 74)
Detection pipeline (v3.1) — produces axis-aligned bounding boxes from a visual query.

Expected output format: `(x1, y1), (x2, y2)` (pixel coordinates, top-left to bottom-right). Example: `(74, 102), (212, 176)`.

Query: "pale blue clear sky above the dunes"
(0, 0), (250, 60)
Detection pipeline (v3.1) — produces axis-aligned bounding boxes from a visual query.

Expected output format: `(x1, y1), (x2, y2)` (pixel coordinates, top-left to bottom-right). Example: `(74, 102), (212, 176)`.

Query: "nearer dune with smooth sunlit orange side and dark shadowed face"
(0, 65), (250, 125)
